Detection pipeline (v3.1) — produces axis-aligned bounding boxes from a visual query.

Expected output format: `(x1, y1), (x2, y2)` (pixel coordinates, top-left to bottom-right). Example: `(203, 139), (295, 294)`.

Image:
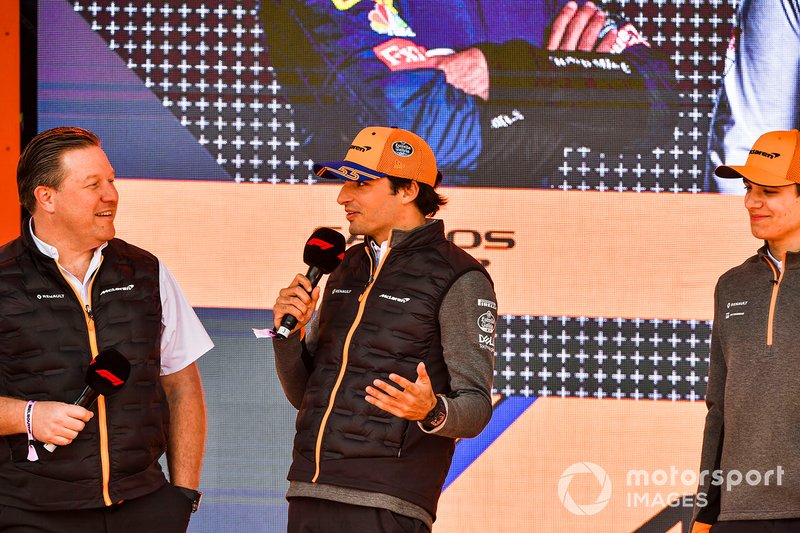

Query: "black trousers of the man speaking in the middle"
(287, 498), (430, 533)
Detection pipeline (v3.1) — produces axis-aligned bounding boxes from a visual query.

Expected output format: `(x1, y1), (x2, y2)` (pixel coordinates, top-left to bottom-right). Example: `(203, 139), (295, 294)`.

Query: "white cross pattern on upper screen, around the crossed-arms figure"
(72, 0), (735, 191)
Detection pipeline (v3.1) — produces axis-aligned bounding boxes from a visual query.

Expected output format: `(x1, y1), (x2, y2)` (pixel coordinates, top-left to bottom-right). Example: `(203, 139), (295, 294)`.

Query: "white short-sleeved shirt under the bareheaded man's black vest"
(30, 220), (214, 376)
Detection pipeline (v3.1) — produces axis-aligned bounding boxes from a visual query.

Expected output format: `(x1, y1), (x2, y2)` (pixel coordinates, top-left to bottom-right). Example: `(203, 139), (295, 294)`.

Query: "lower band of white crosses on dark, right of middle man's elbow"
(494, 315), (712, 401)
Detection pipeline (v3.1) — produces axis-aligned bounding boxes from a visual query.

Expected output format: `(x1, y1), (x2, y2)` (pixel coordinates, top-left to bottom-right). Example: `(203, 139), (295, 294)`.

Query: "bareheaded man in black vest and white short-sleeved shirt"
(0, 128), (213, 533)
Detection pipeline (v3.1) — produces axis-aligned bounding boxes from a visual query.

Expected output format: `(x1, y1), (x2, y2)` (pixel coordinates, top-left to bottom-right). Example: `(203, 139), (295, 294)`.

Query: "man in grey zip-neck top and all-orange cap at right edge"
(692, 130), (800, 533)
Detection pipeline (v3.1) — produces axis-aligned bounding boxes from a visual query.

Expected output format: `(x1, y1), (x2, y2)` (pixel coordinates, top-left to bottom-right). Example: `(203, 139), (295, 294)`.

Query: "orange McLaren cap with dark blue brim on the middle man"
(314, 126), (438, 187)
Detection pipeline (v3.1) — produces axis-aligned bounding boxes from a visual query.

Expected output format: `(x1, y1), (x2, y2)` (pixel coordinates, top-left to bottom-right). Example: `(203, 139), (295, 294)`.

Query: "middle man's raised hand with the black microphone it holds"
(273, 228), (345, 339)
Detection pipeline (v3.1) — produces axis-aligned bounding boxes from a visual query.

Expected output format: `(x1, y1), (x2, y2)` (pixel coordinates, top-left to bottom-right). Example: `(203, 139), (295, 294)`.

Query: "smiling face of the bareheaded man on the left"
(42, 146), (119, 251)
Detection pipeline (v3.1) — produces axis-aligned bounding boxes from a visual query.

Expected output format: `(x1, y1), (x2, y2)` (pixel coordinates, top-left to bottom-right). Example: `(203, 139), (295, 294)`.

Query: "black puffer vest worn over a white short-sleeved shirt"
(0, 224), (169, 510)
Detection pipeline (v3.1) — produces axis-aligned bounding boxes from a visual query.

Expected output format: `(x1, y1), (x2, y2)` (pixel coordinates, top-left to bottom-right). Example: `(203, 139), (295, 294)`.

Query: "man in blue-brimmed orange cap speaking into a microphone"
(273, 127), (497, 532)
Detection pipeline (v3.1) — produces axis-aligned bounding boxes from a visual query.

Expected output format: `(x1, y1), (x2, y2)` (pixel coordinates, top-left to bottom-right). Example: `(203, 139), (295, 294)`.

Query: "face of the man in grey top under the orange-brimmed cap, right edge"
(744, 180), (800, 260)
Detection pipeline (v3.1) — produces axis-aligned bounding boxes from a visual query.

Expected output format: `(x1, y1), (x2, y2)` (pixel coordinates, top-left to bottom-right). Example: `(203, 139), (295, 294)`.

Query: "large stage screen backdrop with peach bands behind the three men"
(38, 0), (758, 532)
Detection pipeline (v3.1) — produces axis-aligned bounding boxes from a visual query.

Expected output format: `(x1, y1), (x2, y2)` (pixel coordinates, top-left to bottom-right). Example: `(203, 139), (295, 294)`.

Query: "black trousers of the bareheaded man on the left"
(0, 483), (192, 533)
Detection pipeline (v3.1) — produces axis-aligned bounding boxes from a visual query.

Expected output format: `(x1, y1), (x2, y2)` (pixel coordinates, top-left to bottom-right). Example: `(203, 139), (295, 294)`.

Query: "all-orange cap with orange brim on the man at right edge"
(714, 130), (800, 187)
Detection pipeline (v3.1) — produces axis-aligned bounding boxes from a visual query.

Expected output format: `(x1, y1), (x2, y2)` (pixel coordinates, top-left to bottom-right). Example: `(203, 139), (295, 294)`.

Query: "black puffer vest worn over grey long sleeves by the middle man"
(289, 220), (488, 516)
